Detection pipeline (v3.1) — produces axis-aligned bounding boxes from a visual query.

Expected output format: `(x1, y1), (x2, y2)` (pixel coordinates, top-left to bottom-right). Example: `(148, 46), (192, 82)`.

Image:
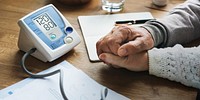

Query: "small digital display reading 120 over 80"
(33, 13), (57, 33)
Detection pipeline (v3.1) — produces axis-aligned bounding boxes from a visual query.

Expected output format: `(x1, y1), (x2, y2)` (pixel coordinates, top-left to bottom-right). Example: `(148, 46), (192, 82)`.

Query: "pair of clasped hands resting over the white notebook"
(96, 25), (154, 71)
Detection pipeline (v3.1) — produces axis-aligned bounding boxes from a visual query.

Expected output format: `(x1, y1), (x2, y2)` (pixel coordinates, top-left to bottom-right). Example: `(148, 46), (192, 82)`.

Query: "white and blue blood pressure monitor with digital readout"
(18, 4), (80, 62)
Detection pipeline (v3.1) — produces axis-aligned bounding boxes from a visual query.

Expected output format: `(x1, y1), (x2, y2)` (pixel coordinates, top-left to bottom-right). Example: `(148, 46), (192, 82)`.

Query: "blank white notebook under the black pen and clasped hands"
(78, 12), (153, 61)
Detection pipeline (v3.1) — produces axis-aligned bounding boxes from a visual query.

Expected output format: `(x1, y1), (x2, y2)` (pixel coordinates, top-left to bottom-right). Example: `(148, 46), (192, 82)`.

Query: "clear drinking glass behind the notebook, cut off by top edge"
(101, 0), (125, 13)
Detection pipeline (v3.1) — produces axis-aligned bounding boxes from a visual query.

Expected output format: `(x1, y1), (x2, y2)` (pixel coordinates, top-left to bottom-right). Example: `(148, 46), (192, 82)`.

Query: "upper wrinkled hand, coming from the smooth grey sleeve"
(96, 25), (154, 56)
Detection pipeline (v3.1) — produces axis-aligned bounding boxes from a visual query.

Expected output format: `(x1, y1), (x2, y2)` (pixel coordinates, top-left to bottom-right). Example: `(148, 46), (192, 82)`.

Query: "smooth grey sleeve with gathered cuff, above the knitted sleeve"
(143, 0), (200, 47)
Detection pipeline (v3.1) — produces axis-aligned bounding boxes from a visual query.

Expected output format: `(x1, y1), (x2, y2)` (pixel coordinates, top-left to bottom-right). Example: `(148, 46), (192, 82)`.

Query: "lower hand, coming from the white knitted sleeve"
(99, 51), (149, 71)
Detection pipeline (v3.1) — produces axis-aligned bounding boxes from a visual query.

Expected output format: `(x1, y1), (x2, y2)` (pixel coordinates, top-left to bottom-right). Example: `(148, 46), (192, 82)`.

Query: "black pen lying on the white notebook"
(115, 19), (153, 24)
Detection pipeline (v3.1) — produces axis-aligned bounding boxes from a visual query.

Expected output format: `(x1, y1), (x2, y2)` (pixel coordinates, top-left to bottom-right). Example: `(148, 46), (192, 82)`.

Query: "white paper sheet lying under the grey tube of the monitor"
(0, 61), (130, 100)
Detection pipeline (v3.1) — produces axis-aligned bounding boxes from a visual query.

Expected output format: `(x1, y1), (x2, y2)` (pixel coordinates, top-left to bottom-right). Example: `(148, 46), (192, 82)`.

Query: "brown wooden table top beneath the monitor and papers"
(0, 0), (197, 100)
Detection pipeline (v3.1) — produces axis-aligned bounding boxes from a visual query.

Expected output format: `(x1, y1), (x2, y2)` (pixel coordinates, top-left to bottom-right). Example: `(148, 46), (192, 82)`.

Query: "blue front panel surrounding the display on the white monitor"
(24, 6), (67, 50)
